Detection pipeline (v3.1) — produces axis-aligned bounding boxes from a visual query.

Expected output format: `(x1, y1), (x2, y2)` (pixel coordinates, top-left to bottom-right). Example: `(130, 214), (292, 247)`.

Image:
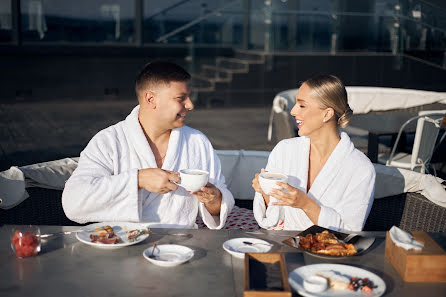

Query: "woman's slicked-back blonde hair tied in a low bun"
(302, 75), (353, 128)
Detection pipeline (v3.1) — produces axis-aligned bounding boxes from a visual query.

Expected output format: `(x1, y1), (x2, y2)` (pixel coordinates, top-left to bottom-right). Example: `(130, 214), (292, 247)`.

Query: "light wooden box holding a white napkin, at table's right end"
(386, 231), (446, 282)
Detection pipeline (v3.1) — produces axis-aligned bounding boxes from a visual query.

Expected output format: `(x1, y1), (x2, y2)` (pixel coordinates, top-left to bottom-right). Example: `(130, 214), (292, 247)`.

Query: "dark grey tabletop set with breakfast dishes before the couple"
(0, 225), (446, 297)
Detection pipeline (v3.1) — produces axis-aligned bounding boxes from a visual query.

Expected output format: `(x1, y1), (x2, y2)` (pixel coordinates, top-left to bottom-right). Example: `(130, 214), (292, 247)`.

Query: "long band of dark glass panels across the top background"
(0, 0), (446, 67)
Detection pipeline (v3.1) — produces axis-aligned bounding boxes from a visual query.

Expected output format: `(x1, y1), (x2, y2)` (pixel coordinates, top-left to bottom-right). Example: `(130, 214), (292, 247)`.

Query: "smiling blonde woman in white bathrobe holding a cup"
(252, 75), (375, 231)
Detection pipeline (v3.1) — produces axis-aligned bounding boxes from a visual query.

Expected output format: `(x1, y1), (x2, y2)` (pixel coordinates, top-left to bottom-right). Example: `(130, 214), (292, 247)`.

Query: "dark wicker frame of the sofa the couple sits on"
(0, 188), (446, 232)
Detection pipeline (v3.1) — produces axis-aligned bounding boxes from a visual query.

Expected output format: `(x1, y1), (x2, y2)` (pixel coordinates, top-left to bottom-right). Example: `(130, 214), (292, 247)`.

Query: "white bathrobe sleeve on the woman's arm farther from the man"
(318, 164), (376, 231)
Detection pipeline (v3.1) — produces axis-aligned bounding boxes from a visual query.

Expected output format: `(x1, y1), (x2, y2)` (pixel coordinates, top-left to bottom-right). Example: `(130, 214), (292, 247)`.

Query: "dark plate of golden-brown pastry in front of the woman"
(283, 225), (375, 259)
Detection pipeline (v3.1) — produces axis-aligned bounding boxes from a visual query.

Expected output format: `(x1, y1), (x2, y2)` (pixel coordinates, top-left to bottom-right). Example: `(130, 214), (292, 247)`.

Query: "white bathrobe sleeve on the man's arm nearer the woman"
(199, 135), (234, 229)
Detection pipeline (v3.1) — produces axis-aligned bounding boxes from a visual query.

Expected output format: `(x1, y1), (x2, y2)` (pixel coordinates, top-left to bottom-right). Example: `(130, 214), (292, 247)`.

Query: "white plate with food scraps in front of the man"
(76, 222), (149, 249)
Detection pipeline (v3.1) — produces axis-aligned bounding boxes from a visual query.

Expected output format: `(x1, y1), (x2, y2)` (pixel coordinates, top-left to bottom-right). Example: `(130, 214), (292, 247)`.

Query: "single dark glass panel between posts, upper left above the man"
(20, 0), (135, 44)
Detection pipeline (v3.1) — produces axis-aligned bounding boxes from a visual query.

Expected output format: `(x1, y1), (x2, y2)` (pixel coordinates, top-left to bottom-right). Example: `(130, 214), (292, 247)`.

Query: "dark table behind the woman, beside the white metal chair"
(350, 111), (417, 163)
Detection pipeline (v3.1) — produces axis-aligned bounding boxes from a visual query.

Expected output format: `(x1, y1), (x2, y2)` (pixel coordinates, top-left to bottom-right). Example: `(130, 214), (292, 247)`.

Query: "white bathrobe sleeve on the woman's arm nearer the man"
(253, 145), (283, 229)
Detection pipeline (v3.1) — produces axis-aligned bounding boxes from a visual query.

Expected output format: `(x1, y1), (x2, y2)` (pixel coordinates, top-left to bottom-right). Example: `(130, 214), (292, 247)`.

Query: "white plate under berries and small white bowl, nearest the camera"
(288, 264), (386, 297)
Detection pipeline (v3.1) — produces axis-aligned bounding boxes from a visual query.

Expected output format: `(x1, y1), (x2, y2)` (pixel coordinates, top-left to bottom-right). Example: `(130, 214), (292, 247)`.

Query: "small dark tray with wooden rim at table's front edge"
(243, 253), (291, 297)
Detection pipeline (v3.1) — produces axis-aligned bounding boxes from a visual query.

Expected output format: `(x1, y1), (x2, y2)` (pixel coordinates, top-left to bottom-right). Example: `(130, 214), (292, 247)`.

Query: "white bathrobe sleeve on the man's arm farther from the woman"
(62, 129), (141, 223)
